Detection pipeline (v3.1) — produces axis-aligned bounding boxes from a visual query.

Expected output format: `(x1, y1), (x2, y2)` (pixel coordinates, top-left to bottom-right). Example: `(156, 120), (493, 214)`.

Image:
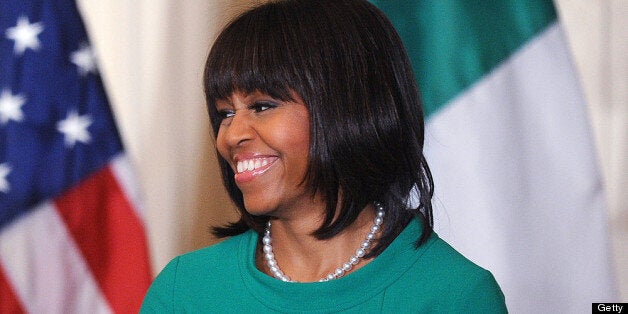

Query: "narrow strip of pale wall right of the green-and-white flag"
(555, 0), (628, 302)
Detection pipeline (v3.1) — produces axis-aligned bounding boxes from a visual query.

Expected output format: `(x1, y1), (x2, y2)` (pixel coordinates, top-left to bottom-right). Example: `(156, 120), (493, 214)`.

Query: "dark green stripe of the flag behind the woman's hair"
(372, 0), (556, 115)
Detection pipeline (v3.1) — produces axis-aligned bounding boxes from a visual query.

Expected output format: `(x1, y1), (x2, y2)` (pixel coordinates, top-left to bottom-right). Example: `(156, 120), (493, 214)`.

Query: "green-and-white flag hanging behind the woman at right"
(372, 0), (615, 313)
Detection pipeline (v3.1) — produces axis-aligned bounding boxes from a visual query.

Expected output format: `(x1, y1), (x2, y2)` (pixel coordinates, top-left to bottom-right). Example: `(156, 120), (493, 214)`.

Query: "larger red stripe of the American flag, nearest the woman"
(55, 167), (152, 313)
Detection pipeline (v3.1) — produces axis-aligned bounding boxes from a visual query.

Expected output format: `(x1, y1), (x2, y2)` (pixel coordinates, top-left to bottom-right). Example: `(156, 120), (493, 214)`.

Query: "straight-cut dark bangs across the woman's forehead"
(205, 2), (307, 105)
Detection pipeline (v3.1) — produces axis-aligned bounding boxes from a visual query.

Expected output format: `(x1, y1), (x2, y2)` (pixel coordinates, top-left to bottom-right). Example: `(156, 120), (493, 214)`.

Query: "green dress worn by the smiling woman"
(140, 221), (507, 313)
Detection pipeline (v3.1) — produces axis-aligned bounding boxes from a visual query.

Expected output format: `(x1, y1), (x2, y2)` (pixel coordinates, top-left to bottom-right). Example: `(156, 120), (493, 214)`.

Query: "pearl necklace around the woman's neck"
(262, 202), (384, 282)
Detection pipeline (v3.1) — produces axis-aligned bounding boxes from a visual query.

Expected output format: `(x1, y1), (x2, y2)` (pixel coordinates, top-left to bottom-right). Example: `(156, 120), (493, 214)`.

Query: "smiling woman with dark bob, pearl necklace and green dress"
(142, 0), (506, 313)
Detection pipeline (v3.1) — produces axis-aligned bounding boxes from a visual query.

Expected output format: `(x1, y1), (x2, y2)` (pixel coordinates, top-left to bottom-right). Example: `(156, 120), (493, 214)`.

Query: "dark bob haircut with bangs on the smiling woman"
(204, 0), (434, 256)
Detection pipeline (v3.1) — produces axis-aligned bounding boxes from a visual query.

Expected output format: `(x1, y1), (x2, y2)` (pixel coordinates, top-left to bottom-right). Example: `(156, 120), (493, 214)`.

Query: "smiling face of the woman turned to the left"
(216, 92), (311, 215)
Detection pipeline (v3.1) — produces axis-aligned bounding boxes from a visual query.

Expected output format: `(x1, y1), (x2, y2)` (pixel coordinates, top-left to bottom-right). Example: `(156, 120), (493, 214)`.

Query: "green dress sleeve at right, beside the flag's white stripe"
(451, 271), (508, 313)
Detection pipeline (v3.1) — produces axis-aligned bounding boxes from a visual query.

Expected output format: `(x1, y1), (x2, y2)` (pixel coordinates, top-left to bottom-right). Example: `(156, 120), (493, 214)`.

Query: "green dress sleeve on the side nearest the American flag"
(140, 257), (179, 314)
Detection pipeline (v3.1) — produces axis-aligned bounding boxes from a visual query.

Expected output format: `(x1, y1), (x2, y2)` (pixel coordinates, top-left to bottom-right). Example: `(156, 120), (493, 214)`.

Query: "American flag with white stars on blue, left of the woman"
(0, 0), (152, 313)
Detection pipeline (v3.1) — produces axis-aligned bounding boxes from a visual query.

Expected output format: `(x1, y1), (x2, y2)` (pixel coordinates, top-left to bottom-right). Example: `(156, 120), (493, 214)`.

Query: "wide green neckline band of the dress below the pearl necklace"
(237, 219), (436, 312)
